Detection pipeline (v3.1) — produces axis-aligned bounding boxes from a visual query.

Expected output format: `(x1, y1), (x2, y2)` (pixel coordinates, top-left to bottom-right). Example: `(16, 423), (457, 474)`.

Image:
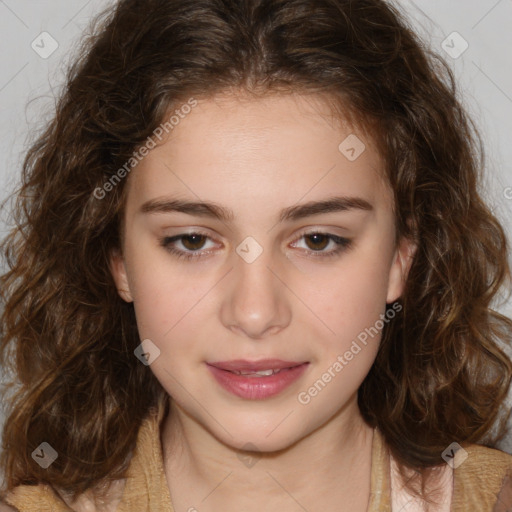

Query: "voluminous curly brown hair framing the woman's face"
(0, 0), (512, 504)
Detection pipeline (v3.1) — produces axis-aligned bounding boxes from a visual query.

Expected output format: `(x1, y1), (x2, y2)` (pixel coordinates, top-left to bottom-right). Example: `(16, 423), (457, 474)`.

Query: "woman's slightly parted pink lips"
(207, 359), (309, 400)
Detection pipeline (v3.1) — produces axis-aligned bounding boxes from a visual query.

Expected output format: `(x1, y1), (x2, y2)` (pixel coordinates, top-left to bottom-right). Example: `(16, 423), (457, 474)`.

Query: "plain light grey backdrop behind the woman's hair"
(0, 0), (512, 464)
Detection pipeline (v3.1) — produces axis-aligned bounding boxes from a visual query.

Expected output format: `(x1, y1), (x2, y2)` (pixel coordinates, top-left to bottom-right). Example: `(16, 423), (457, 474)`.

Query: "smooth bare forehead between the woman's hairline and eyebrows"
(124, 94), (391, 216)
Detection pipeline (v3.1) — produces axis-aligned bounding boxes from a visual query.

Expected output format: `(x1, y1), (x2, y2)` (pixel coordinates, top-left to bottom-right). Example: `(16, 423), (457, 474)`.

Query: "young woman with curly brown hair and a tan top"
(0, 0), (512, 512)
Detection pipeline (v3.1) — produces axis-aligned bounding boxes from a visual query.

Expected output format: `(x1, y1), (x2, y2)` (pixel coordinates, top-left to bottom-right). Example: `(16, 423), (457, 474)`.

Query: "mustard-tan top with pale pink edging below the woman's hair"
(4, 400), (512, 512)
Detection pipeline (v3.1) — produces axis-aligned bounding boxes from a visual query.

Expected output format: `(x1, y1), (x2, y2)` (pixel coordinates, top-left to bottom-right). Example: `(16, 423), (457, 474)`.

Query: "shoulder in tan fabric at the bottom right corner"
(451, 444), (512, 510)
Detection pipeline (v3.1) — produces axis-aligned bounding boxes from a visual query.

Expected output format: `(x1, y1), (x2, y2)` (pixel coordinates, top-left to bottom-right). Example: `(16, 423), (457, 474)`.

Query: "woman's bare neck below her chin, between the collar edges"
(161, 396), (373, 512)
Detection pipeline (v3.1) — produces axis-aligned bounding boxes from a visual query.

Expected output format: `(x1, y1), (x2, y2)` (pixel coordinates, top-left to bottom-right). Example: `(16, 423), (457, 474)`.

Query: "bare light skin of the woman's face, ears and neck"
(111, 93), (414, 512)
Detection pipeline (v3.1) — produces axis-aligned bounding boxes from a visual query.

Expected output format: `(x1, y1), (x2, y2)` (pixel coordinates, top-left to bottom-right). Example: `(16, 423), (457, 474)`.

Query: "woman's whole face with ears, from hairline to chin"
(111, 95), (412, 451)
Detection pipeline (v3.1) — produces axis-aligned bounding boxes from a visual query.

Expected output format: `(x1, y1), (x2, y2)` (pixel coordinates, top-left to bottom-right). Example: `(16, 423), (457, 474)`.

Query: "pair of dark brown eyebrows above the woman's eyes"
(140, 196), (373, 222)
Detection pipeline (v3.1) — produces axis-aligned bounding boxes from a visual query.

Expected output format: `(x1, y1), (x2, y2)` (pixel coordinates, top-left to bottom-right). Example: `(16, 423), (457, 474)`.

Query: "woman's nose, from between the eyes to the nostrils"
(220, 244), (291, 339)
